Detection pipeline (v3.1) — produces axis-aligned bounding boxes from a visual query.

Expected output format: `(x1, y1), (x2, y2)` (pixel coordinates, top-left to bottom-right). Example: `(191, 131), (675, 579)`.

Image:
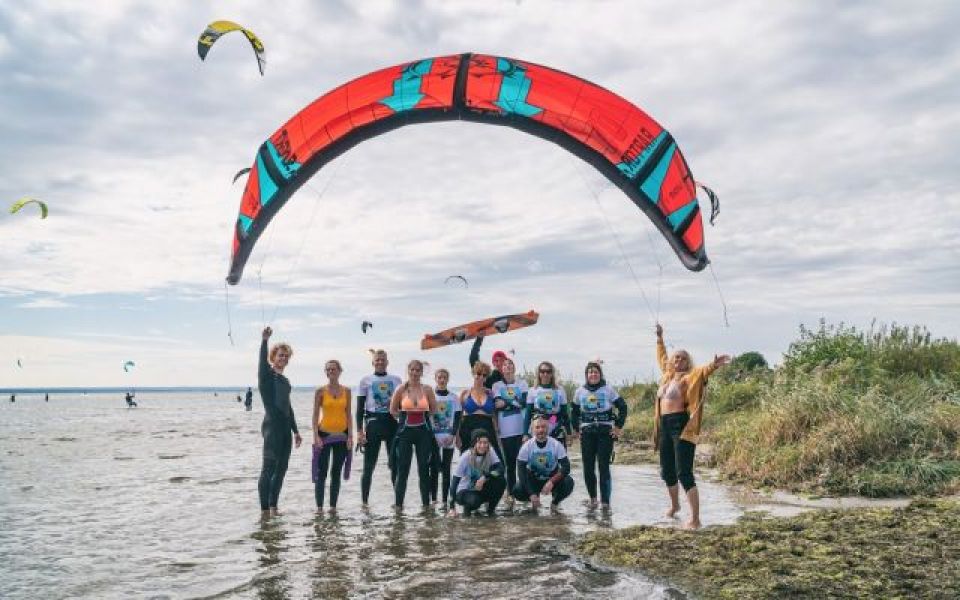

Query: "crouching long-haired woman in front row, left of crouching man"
(448, 429), (507, 517)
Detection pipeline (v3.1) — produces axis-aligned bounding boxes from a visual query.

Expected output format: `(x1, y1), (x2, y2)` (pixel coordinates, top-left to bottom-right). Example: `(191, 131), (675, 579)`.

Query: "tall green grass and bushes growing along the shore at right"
(621, 322), (960, 497)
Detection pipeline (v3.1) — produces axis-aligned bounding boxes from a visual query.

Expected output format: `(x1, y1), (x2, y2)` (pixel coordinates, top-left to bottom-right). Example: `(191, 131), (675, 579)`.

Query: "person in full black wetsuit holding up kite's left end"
(257, 327), (303, 515)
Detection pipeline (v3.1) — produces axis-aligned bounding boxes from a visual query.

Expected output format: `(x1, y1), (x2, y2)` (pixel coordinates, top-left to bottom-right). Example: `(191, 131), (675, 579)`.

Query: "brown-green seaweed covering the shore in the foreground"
(577, 500), (960, 599)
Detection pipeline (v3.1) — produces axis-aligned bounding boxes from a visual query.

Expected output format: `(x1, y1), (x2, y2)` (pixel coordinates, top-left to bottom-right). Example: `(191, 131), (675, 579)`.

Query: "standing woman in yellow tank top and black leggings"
(313, 360), (353, 510)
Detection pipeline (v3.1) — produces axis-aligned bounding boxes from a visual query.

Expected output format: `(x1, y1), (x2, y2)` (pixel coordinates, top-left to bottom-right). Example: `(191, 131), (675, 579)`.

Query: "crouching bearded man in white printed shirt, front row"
(513, 415), (573, 512)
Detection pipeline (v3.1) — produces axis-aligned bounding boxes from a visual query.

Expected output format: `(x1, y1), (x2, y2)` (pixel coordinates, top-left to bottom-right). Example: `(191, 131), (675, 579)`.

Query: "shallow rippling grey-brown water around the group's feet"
(0, 392), (743, 598)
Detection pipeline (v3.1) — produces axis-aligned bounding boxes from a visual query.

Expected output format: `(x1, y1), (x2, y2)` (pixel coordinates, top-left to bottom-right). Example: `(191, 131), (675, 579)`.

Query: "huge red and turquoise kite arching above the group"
(227, 54), (708, 284)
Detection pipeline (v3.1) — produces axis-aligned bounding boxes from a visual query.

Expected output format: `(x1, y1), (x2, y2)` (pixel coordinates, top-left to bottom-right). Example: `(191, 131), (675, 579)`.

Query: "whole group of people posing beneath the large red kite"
(258, 325), (730, 528)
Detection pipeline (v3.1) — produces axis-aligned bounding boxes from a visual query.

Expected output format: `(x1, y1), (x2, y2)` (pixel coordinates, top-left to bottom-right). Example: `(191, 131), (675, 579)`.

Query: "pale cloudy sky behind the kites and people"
(0, 0), (960, 388)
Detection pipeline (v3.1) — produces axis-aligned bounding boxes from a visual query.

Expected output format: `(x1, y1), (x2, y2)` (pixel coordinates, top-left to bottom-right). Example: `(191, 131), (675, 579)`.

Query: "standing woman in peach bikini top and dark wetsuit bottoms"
(390, 360), (437, 509)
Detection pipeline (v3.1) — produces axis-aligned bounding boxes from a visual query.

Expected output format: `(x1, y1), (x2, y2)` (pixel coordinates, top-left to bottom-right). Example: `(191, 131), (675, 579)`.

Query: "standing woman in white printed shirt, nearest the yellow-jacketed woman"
(571, 361), (627, 510)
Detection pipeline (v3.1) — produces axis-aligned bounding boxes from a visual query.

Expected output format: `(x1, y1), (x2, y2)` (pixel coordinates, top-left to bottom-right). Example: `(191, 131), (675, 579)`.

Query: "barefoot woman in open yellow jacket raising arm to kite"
(653, 323), (730, 529)
